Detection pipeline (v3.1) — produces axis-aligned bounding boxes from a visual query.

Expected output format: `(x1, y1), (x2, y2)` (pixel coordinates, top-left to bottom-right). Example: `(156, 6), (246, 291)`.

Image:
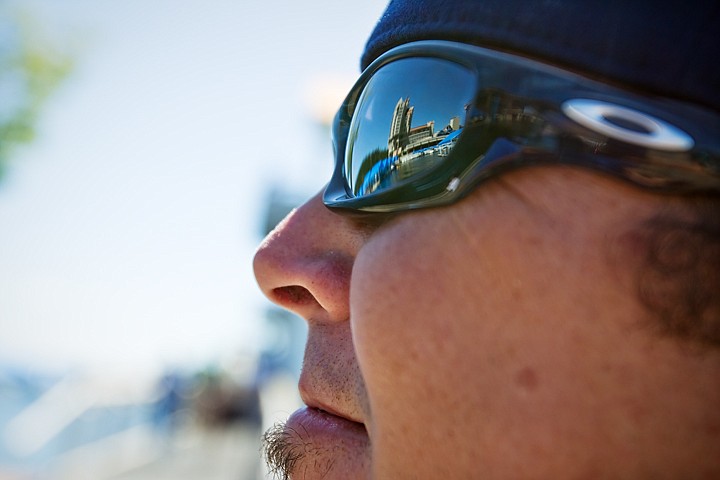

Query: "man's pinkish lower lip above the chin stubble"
(286, 407), (368, 445)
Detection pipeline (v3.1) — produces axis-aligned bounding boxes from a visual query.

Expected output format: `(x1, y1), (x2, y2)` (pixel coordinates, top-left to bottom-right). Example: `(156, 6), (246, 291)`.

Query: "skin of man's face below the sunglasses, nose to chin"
(255, 167), (720, 479)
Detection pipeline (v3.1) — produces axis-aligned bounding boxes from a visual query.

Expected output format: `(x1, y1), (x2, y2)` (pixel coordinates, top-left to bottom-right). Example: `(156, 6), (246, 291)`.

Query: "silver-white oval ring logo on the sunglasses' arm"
(562, 98), (695, 152)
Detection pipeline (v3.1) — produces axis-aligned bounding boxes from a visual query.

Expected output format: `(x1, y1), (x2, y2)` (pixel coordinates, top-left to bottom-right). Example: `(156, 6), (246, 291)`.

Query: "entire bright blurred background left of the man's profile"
(0, 0), (386, 480)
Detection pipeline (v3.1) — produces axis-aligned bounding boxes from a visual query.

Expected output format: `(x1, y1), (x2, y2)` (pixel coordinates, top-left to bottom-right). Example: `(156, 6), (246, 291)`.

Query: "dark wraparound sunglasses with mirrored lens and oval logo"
(323, 41), (720, 212)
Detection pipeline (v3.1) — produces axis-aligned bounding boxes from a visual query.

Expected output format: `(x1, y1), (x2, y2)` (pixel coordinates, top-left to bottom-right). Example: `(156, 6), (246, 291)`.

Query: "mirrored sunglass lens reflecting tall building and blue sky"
(345, 58), (475, 197)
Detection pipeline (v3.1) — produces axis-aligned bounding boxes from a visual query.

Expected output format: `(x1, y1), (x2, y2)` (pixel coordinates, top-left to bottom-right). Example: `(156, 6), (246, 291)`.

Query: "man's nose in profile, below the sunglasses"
(253, 190), (365, 323)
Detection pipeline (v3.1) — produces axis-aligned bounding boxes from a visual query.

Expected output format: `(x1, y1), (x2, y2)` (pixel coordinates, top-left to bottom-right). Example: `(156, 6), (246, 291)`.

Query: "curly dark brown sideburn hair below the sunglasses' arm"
(638, 194), (720, 348)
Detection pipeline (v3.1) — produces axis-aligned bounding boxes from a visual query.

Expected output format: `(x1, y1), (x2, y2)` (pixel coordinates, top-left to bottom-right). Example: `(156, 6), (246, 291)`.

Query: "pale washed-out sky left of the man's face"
(0, 0), (386, 369)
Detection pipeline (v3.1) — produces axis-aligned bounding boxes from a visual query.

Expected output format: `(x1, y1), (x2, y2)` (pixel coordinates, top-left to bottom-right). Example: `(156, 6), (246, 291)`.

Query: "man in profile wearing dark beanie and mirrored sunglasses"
(254, 0), (720, 479)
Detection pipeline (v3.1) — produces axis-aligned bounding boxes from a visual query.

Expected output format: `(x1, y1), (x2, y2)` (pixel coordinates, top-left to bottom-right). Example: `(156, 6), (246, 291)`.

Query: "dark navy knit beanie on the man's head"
(361, 0), (720, 111)
